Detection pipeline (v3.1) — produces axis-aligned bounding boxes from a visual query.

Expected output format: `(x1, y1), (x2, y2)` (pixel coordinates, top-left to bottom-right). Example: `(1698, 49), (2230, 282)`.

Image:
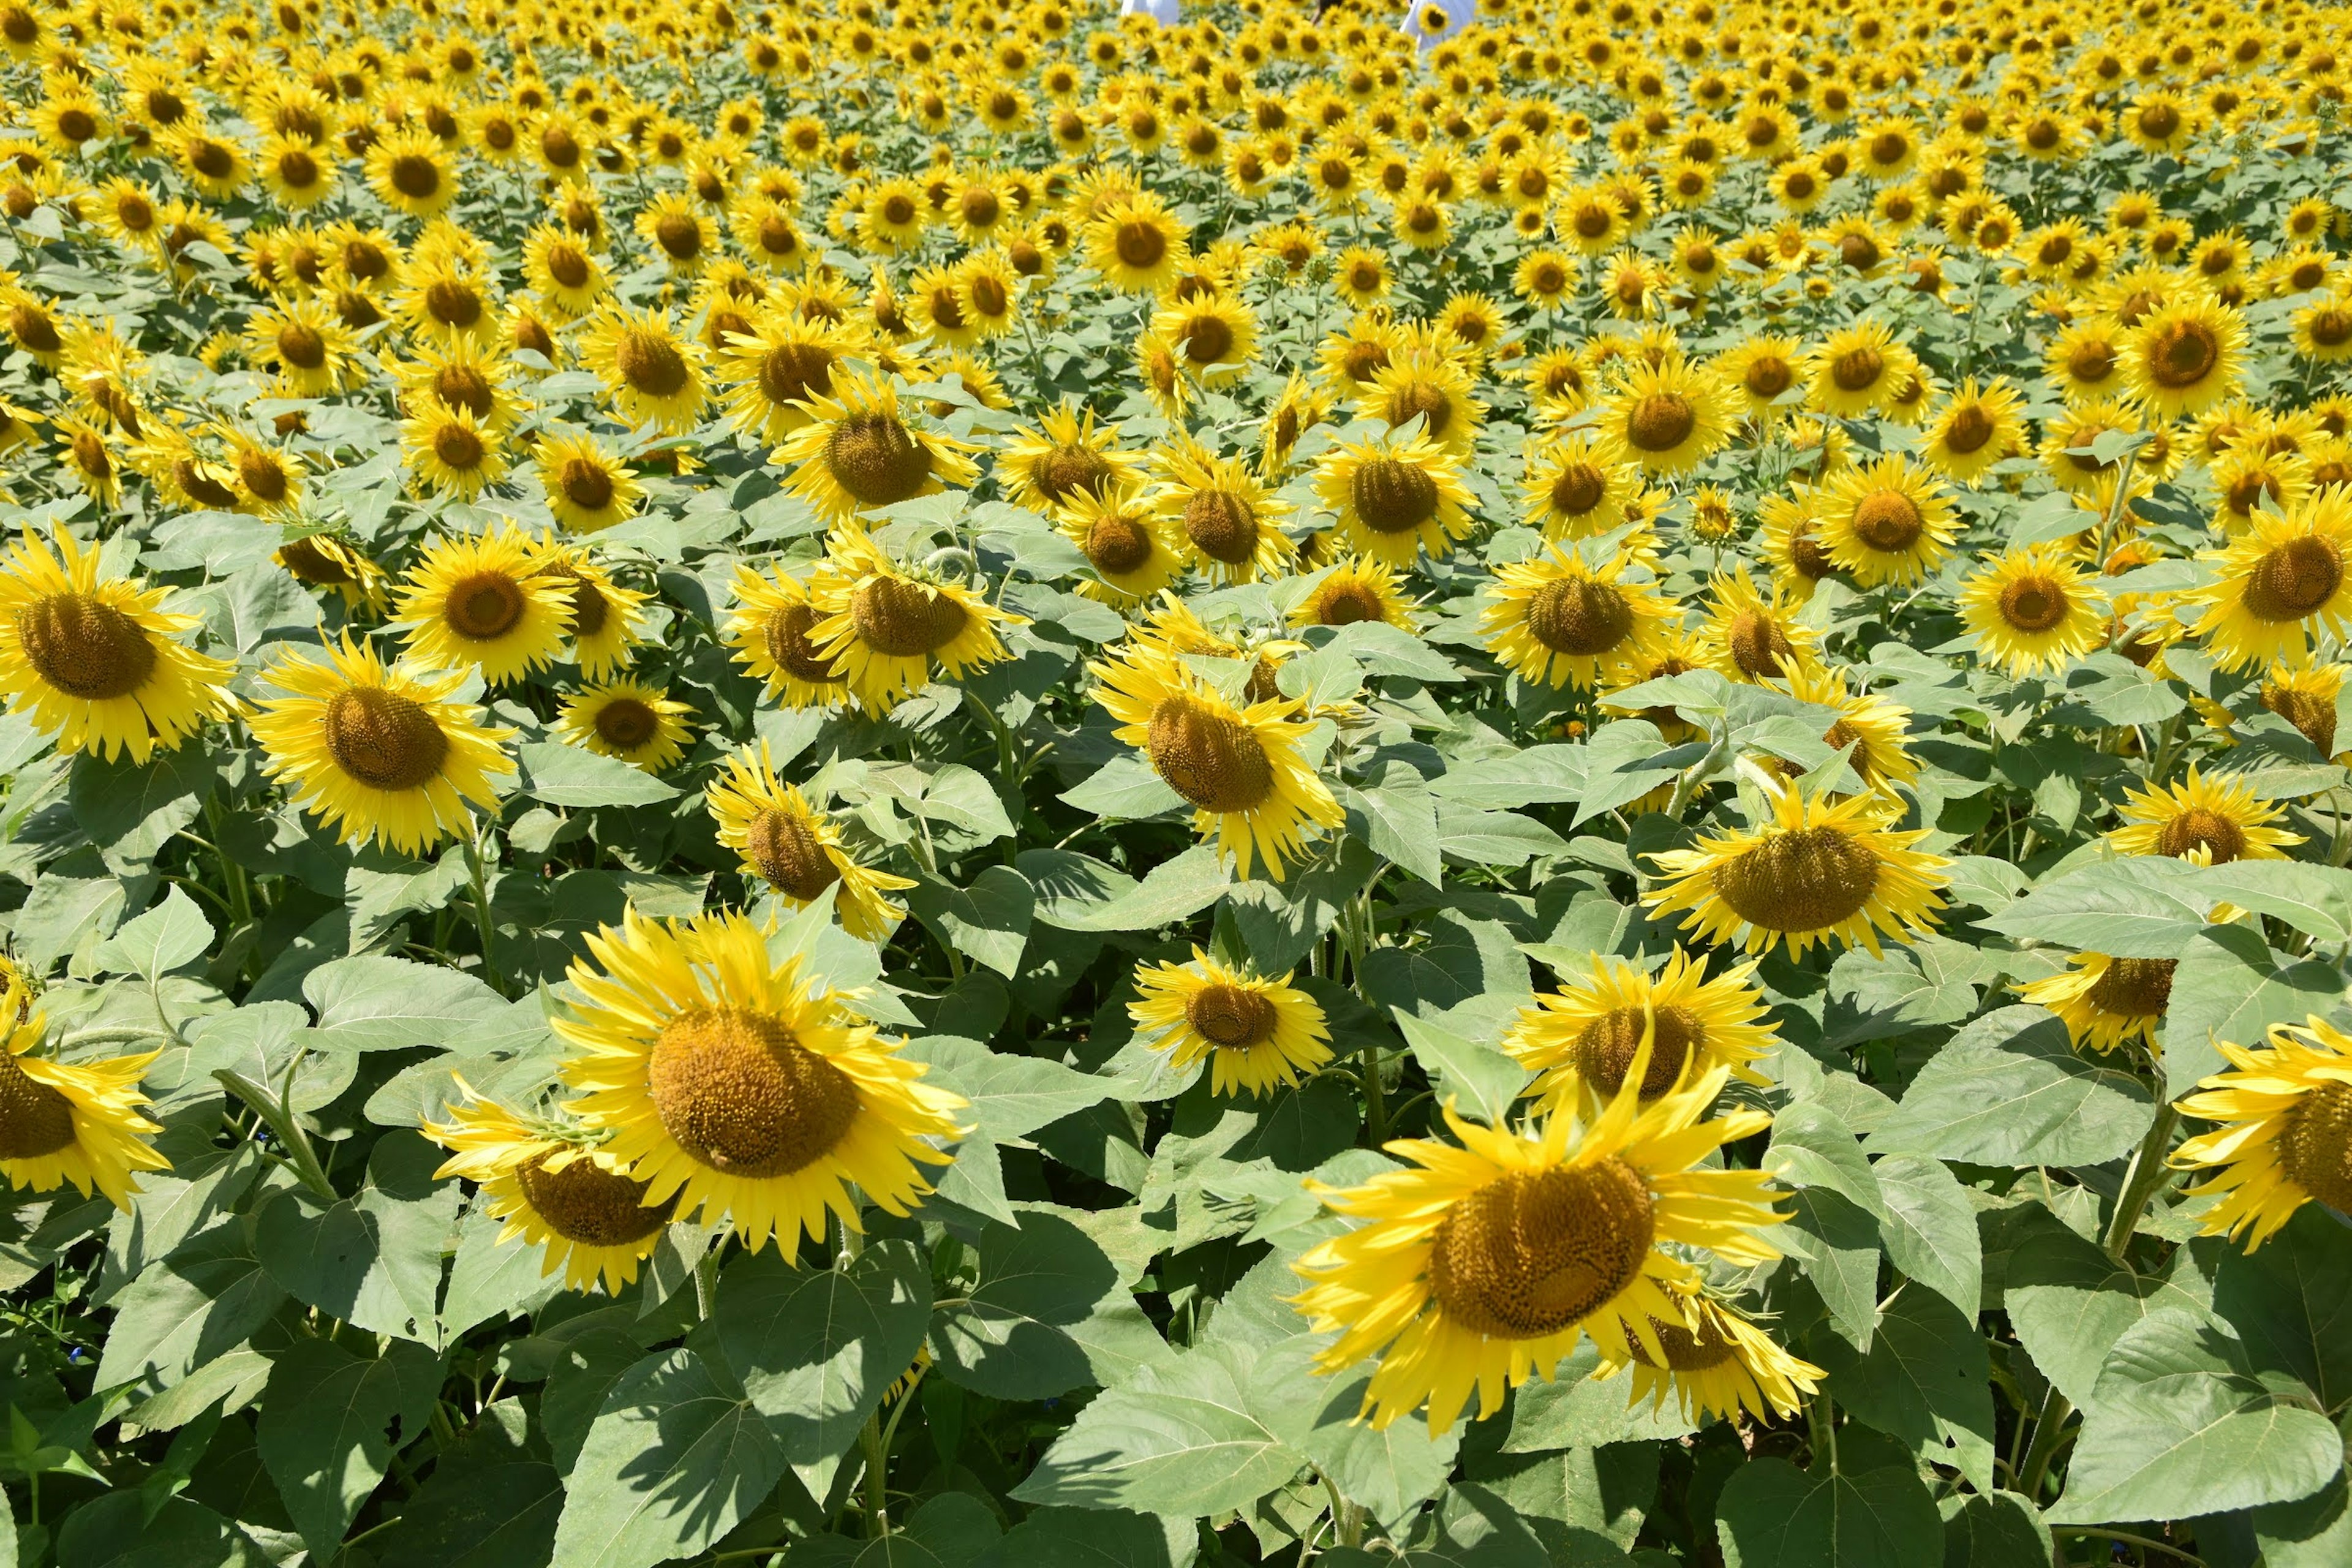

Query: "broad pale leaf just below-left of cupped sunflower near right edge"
(1868, 1006), (2152, 1166)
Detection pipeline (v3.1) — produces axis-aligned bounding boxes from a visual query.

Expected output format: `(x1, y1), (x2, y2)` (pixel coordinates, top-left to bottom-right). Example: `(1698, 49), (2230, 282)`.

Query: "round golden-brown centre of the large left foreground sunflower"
(647, 1006), (859, 1178)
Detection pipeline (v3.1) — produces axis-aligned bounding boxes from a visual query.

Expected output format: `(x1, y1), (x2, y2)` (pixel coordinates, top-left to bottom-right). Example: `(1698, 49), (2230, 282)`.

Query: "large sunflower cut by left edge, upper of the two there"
(0, 527), (238, 766)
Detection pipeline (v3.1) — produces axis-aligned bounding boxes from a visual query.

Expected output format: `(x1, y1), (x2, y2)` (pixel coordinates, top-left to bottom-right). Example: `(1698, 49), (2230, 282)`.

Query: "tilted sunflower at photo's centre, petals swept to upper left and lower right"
(1091, 649), (1345, 881)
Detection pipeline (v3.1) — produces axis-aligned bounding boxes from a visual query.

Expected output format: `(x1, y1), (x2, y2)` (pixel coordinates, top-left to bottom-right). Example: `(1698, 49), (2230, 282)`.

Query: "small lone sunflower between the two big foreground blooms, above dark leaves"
(1126, 948), (1331, 1096)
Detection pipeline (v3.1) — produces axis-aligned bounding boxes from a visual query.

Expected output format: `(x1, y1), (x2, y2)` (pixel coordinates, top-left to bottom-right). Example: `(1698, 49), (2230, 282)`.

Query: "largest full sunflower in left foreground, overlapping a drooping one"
(555, 910), (969, 1260)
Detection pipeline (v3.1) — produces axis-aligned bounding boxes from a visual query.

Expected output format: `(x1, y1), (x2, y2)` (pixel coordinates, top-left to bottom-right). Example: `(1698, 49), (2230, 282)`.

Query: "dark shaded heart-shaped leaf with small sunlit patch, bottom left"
(257, 1340), (442, 1561)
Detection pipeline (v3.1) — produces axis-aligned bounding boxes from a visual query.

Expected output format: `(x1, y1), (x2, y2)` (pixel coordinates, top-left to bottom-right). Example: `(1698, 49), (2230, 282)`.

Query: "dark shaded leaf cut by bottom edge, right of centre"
(1714, 1460), (1943, 1568)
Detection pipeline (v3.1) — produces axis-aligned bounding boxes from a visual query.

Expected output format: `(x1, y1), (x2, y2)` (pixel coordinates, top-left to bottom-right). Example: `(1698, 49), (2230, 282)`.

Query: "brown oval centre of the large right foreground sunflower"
(1430, 1159), (1656, 1340)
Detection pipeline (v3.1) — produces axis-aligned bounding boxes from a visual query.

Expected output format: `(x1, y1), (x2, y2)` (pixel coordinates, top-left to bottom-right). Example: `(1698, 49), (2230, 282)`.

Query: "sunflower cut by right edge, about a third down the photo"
(2183, 496), (2352, 670)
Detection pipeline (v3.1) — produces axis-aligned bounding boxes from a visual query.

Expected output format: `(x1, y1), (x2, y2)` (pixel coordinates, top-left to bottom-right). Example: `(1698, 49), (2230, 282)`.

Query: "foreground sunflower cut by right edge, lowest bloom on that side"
(2171, 1018), (2352, 1253)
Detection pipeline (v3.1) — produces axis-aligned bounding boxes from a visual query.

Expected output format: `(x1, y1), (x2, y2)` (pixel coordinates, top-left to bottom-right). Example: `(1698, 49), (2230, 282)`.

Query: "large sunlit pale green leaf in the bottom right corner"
(2051, 1310), (2345, 1523)
